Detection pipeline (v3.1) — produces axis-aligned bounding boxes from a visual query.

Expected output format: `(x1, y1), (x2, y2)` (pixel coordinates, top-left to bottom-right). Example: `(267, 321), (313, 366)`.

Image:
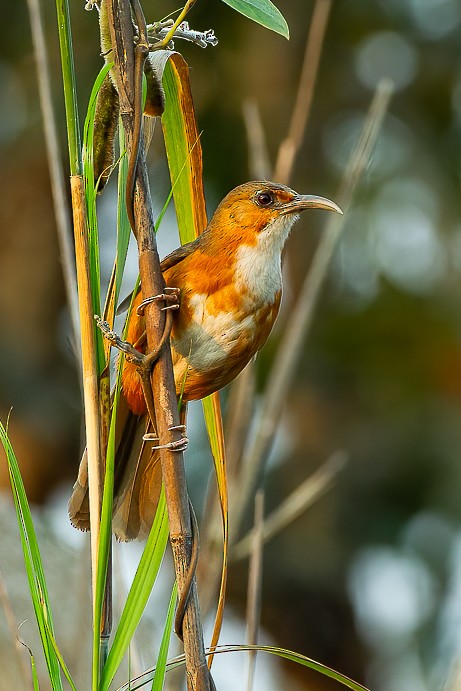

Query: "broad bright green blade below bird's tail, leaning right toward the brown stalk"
(99, 489), (168, 691)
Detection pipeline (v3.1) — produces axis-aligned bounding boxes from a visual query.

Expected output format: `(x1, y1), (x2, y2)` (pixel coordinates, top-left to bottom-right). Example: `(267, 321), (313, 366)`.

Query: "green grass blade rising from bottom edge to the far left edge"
(0, 422), (62, 691)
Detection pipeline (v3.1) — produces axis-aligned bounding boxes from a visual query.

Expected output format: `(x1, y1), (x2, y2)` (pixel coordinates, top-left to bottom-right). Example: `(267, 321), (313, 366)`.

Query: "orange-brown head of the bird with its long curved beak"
(210, 180), (342, 251)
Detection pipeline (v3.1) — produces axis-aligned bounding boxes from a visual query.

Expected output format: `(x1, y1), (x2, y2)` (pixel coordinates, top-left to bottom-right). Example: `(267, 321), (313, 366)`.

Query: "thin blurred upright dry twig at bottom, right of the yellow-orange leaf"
(246, 490), (264, 691)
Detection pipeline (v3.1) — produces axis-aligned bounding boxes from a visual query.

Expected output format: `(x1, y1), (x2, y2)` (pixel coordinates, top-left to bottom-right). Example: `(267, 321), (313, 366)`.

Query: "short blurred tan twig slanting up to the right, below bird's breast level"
(231, 451), (347, 564)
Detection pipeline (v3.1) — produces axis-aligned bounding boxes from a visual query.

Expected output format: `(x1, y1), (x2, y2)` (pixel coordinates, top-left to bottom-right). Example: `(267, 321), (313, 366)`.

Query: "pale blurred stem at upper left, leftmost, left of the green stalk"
(27, 0), (80, 352)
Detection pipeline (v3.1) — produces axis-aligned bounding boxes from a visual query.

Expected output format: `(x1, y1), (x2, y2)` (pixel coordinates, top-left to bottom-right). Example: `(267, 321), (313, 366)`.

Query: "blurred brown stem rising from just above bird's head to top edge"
(274, 0), (331, 185)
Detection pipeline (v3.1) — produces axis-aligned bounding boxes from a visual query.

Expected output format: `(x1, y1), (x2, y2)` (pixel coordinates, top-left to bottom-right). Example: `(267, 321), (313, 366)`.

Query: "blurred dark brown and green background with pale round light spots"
(0, 0), (461, 691)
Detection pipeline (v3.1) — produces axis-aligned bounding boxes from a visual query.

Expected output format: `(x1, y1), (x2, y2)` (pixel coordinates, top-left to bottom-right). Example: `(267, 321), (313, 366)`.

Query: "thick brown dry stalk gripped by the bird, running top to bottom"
(103, 0), (214, 691)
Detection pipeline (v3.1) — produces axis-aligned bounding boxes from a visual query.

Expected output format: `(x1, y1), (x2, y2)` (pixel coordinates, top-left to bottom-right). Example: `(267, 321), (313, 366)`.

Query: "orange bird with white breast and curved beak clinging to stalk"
(69, 181), (342, 540)
